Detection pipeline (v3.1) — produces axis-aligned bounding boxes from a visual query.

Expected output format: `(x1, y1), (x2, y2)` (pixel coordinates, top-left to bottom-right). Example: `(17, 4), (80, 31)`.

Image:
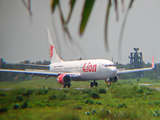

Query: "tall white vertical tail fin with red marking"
(47, 28), (63, 64)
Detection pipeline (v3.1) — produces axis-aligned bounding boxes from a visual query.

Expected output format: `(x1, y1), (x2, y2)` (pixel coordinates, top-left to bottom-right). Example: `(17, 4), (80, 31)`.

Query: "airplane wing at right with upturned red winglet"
(117, 56), (155, 75)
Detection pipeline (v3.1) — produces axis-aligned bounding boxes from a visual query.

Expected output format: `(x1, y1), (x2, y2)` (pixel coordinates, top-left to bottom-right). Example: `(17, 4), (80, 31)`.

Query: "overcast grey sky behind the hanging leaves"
(0, 0), (160, 63)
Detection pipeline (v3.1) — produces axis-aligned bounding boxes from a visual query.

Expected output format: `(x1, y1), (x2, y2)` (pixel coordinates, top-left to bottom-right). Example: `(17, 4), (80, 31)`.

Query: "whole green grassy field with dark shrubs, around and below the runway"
(0, 78), (160, 120)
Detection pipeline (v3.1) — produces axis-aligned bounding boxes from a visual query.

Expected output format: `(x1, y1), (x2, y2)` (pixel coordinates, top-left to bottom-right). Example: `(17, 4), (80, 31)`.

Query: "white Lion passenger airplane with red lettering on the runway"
(0, 28), (155, 88)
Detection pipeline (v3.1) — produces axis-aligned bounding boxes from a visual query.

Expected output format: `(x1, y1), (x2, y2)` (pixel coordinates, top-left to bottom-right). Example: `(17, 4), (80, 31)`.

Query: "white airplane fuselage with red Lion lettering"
(50, 59), (117, 81)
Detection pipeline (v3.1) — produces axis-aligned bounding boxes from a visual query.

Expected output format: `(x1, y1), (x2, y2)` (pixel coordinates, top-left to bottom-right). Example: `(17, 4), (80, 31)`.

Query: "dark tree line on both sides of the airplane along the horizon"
(0, 58), (160, 81)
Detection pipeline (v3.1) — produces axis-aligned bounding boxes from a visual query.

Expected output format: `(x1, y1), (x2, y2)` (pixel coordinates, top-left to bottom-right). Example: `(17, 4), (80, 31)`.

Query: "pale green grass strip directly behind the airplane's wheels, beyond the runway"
(0, 77), (160, 89)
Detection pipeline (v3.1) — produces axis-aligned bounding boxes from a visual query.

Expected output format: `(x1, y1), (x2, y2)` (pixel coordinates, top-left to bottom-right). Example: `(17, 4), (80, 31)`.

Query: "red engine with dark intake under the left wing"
(57, 74), (71, 84)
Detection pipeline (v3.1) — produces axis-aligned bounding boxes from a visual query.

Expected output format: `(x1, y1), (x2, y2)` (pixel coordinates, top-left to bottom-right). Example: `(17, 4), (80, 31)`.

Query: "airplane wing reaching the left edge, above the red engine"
(0, 69), (80, 78)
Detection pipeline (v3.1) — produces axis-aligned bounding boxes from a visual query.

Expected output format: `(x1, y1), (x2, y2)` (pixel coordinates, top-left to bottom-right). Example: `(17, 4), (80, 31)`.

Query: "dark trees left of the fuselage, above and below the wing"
(0, 58), (50, 81)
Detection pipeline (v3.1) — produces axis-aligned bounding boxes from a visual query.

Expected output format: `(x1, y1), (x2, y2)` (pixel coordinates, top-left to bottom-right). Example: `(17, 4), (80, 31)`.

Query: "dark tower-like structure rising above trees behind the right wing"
(128, 48), (143, 77)
